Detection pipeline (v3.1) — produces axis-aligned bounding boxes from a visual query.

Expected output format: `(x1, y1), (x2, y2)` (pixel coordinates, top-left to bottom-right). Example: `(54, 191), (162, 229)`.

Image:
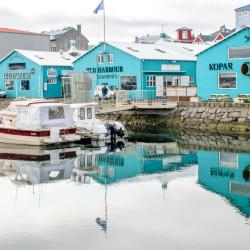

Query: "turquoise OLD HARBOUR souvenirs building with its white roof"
(73, 41), (204, 93)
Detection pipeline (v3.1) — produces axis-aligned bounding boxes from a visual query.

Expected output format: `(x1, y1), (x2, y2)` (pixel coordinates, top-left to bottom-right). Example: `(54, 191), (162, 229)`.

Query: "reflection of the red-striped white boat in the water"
(0, 144), (77, 185)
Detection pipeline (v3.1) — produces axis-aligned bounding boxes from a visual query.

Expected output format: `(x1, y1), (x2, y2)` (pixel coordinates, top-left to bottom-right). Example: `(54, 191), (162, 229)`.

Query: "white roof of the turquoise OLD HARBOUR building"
(108, 40), (208, 61)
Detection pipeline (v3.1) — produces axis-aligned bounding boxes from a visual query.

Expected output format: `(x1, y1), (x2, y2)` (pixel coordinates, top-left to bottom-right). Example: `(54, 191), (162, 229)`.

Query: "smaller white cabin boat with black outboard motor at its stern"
(71, 102), (126, 140)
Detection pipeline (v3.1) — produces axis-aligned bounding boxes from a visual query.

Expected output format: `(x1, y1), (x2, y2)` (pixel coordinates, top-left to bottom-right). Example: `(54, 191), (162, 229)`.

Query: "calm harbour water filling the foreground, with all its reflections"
(0, 133), (250, 250)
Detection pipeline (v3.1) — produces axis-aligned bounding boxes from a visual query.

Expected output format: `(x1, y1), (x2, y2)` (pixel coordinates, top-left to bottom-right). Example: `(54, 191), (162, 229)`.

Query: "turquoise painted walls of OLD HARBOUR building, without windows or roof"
(74, 44), (196, 93)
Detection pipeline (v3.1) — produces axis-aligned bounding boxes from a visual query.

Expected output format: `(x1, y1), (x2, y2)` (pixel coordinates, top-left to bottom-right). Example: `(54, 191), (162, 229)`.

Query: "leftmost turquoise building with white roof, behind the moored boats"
(0, 50), (75, 98)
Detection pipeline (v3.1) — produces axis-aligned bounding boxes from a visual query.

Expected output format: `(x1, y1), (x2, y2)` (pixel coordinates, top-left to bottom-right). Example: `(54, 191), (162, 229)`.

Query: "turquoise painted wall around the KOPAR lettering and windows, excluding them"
(197, 28), (250, 99)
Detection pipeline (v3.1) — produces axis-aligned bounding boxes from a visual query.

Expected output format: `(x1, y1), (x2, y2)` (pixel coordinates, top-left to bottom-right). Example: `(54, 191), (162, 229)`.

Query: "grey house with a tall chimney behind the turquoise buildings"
(42, 25), (89, 51)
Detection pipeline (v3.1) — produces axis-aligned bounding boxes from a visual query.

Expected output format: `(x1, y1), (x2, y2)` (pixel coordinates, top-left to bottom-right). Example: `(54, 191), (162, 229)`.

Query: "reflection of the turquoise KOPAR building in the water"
(197, 151), (250, 217)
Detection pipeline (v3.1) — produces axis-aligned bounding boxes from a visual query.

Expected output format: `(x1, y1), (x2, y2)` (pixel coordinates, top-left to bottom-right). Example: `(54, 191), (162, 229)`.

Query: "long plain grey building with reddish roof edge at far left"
(0, 28), (50, 59)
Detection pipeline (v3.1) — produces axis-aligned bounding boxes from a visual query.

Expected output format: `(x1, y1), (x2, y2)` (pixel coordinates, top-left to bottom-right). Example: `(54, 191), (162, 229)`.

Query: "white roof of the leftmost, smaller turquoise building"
(6, 50), (75, 67)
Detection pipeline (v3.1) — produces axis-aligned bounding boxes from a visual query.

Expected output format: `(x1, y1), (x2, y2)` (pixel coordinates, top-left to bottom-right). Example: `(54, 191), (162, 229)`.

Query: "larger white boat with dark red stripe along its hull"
(0, 99), (80, 145)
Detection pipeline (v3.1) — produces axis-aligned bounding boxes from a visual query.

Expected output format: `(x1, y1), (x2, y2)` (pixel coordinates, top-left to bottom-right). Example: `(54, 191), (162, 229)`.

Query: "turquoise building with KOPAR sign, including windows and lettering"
(197, 27), (250, 99)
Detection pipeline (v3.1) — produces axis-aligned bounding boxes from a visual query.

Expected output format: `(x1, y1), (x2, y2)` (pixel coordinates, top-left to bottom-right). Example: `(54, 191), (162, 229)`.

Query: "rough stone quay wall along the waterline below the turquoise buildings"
(101, 102), (250, 134)
